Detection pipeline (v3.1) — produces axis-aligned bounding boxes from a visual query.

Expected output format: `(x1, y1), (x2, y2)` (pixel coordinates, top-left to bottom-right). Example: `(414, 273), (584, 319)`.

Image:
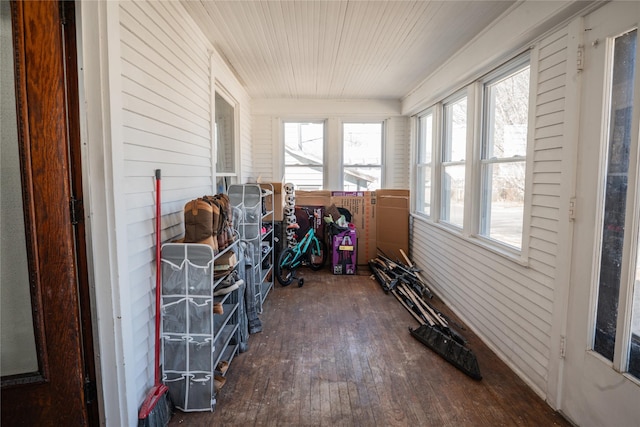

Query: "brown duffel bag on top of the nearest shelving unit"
(184, 198), (220, 253)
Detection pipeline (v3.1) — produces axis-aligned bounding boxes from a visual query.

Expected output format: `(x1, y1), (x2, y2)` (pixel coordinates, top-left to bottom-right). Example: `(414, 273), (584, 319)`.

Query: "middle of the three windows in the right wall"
(440, 96), (467, 228)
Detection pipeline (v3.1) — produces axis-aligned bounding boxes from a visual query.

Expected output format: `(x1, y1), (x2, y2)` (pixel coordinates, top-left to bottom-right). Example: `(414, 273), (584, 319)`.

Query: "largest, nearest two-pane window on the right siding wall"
(479, 58), (530, 250)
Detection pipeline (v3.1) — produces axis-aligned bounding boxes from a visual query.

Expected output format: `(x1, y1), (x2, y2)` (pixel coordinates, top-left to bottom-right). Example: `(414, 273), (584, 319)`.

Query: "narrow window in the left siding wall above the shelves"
(214, 90), (236, 192)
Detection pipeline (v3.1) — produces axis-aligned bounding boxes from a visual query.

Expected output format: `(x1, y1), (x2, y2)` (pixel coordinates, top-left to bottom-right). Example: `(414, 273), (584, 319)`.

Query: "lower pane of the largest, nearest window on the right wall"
(481, 162), (525, 249)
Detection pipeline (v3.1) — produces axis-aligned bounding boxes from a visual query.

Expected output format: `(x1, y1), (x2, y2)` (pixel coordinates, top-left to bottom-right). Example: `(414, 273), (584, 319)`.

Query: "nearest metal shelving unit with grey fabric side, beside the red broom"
(161, 239), (244, 412)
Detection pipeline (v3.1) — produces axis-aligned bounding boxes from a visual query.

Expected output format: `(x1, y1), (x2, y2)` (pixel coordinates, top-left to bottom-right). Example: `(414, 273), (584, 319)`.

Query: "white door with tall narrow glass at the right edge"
(560, 2), (640, 426)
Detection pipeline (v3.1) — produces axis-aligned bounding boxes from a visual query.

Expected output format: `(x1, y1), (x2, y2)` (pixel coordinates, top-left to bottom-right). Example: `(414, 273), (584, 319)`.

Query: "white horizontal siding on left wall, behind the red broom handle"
(120, 2), (213, 412)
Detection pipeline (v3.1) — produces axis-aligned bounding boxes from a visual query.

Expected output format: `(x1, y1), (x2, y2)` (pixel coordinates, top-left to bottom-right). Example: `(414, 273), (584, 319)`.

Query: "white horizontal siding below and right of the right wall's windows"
(411, 30), (570, 397)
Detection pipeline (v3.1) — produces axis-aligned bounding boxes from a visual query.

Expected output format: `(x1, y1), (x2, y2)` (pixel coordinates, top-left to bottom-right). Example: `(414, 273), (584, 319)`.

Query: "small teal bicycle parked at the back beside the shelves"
(275, 226), (327, 287)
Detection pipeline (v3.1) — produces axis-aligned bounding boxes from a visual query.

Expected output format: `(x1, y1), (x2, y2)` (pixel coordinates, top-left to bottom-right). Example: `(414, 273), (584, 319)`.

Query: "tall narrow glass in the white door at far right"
(593, 30), (640, 378)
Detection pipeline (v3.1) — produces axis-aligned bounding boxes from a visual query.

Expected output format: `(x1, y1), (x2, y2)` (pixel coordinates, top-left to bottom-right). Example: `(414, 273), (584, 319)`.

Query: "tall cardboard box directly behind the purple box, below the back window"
(329, 191), (377, 265)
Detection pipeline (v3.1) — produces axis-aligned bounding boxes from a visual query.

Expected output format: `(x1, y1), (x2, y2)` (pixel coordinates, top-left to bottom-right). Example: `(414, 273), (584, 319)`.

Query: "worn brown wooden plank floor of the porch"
(170, 269), (570, 426)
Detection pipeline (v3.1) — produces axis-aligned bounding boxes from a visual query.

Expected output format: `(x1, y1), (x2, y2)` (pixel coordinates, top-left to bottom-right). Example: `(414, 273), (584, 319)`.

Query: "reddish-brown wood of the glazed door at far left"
(2, 1), (97, 426)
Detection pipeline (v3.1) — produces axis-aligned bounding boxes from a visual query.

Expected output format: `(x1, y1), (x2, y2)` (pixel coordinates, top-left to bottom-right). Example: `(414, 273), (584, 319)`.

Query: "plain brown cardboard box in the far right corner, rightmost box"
(376, 190), (410, 260)
